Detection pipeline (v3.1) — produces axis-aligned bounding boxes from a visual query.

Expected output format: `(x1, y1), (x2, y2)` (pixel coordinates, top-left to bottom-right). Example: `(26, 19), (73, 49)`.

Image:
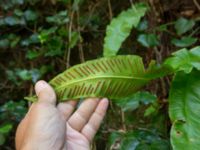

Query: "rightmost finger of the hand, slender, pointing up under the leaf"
(81, 98), (109, 141)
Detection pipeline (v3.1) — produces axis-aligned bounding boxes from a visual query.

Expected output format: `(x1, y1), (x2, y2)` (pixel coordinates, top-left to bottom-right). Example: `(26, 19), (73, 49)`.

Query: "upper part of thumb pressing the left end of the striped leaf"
(35, 80), (56, 105)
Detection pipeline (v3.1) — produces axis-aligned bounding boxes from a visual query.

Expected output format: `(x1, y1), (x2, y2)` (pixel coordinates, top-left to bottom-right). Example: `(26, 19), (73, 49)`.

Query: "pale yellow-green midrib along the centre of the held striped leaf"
(55, 75), (149, 91)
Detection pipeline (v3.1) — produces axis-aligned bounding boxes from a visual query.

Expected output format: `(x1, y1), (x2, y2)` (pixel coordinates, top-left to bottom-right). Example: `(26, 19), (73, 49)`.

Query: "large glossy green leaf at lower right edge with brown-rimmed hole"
(169, 70), (200, 150)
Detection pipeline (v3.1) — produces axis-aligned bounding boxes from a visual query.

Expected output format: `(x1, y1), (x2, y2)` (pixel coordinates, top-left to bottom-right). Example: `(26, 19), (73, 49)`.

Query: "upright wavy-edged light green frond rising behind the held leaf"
(103, 3), (147, 56)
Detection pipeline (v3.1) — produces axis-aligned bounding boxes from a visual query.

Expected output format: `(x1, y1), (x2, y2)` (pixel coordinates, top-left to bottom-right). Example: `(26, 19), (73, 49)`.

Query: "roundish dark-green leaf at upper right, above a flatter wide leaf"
(175, 17), (195, 35)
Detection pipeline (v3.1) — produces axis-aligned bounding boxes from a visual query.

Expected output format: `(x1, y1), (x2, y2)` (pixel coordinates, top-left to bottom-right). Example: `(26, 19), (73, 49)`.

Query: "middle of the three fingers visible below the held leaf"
(68, 98), (99, 131)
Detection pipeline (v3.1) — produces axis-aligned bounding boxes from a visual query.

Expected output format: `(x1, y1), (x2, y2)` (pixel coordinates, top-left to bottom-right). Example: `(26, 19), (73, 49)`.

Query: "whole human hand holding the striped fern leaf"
(16, 81), (108, 150)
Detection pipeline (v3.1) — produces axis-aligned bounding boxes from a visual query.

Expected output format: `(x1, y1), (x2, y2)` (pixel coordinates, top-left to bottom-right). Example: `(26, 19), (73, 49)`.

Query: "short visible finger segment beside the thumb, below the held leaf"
(57, 101), (77, 121)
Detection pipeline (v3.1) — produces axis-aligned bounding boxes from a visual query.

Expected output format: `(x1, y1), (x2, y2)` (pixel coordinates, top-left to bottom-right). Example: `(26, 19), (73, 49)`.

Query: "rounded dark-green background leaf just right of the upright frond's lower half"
(137, 34), (159, 48)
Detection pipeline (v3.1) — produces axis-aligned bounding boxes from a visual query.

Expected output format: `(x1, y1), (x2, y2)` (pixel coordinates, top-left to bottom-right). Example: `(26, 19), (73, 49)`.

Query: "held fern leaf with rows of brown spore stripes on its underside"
(25, 55), (159, 101)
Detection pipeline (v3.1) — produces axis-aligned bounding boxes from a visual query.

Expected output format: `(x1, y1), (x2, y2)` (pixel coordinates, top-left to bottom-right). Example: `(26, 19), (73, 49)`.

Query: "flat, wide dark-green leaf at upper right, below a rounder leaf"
(171, 36), (197, 47)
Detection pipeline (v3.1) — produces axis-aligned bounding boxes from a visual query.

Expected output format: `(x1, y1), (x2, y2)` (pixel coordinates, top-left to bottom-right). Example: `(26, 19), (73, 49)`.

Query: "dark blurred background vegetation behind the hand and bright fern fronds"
(0, 0), (200, 150)
